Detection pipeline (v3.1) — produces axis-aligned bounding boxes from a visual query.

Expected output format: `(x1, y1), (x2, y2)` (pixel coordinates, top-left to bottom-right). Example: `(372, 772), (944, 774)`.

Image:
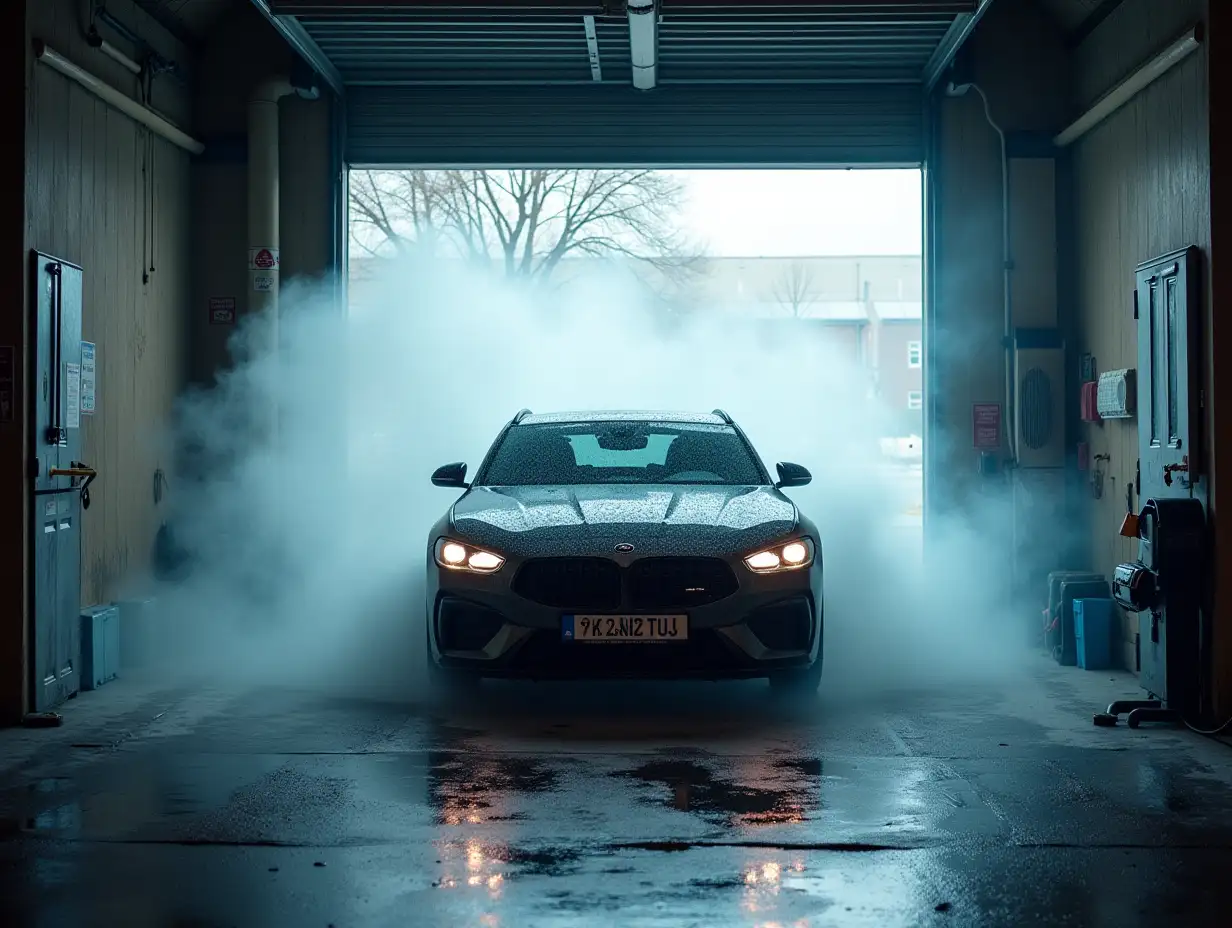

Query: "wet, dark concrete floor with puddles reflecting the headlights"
(0, 668), (1232, 928)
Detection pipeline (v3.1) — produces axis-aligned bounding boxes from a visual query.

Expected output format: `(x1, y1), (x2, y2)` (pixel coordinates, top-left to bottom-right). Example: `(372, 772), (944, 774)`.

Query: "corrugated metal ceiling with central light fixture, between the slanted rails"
(270, 0), (976, 86)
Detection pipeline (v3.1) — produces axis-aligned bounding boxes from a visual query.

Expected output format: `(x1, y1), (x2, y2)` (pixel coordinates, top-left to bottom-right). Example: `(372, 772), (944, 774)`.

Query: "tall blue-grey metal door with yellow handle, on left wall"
(31, 251), (92, 711)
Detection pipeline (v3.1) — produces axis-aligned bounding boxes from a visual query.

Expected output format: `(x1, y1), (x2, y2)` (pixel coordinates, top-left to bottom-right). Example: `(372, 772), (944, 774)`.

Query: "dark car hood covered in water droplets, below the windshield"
(452, 484), (797, 557)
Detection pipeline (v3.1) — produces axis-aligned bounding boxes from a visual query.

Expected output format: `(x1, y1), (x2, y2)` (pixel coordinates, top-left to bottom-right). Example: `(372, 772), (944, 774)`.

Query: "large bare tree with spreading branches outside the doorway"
(351, 170), (700, 282)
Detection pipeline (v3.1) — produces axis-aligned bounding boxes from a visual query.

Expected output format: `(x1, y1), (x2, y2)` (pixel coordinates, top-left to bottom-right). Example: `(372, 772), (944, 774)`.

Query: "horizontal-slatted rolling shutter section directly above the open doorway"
(346, 84), (924, 168)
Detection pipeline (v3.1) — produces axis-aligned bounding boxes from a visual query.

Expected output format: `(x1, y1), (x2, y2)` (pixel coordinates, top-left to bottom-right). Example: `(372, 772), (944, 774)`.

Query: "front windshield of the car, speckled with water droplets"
(482, 420), (765, 487)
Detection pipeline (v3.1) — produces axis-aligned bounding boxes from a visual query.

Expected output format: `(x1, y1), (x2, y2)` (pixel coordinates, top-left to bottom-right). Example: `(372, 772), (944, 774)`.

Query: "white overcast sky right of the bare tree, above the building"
(671, 170), (923, 258)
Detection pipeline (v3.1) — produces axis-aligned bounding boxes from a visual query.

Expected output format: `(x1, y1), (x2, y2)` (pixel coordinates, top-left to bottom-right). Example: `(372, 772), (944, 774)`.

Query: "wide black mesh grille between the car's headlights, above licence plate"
(514, 557), (739, 611)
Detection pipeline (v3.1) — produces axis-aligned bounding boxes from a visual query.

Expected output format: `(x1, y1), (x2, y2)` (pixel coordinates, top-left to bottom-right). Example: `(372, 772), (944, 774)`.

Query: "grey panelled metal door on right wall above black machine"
(1137, 246), (1201, 499)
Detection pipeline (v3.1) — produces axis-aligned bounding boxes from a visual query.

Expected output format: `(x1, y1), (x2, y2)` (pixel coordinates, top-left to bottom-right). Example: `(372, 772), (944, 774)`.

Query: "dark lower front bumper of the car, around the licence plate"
(426, 562), (824, 680)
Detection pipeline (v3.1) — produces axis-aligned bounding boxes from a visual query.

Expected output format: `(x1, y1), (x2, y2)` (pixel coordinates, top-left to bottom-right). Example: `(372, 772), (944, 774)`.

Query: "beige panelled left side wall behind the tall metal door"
(27, 0), (191, 604)
